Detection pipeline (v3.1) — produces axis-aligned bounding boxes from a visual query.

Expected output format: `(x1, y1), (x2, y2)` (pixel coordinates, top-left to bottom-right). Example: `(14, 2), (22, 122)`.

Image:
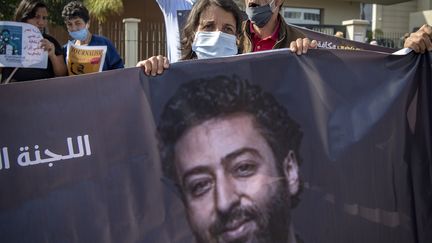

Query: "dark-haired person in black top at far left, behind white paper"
(1, 0), (67, 82)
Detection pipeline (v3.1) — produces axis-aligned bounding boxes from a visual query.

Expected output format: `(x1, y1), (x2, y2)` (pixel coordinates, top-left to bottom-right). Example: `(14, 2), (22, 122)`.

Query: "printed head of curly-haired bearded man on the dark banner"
(158, 76), (302, 243)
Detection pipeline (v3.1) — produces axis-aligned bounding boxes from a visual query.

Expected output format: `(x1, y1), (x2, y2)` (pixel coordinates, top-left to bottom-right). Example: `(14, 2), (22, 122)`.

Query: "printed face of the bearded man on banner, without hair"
(175, 113), (298, 242)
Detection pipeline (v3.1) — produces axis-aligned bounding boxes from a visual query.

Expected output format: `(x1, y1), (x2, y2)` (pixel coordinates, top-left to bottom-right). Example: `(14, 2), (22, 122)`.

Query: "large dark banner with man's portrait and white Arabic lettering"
(0, 49), (432, 243)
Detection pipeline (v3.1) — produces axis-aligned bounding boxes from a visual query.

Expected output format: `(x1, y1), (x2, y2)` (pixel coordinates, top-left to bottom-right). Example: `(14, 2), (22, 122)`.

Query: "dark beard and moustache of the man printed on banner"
(194, 177), (291, 243)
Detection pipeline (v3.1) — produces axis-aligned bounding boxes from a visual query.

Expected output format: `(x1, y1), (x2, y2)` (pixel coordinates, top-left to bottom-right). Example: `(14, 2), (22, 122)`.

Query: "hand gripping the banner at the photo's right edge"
(404, 24), (432, 53)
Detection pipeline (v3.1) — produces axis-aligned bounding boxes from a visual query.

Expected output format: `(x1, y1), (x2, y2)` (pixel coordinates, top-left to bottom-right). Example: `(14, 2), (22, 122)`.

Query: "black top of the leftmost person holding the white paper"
(1, 34), (63, 82)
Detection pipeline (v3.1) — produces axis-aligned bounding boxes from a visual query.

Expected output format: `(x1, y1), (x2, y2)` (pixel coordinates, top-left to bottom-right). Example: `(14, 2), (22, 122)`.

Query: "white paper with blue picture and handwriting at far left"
(0, 21), (48, 68)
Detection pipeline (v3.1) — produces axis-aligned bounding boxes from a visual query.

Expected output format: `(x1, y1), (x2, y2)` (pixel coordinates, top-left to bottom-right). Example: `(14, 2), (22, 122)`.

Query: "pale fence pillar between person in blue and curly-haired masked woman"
(123, 18), (141, 67)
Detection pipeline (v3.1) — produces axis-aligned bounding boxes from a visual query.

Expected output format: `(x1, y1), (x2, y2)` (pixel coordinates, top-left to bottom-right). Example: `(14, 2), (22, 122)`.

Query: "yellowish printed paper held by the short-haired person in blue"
(66, 42), (107, 75)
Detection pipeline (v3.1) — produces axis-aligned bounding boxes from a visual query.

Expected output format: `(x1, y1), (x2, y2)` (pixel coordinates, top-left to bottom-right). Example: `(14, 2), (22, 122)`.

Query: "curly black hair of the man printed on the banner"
(157, 76), (303, 198)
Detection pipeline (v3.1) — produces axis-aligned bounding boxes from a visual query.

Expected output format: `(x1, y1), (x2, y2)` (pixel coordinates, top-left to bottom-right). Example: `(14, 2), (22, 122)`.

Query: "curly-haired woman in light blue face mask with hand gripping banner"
(137, 0), (241, 76)
